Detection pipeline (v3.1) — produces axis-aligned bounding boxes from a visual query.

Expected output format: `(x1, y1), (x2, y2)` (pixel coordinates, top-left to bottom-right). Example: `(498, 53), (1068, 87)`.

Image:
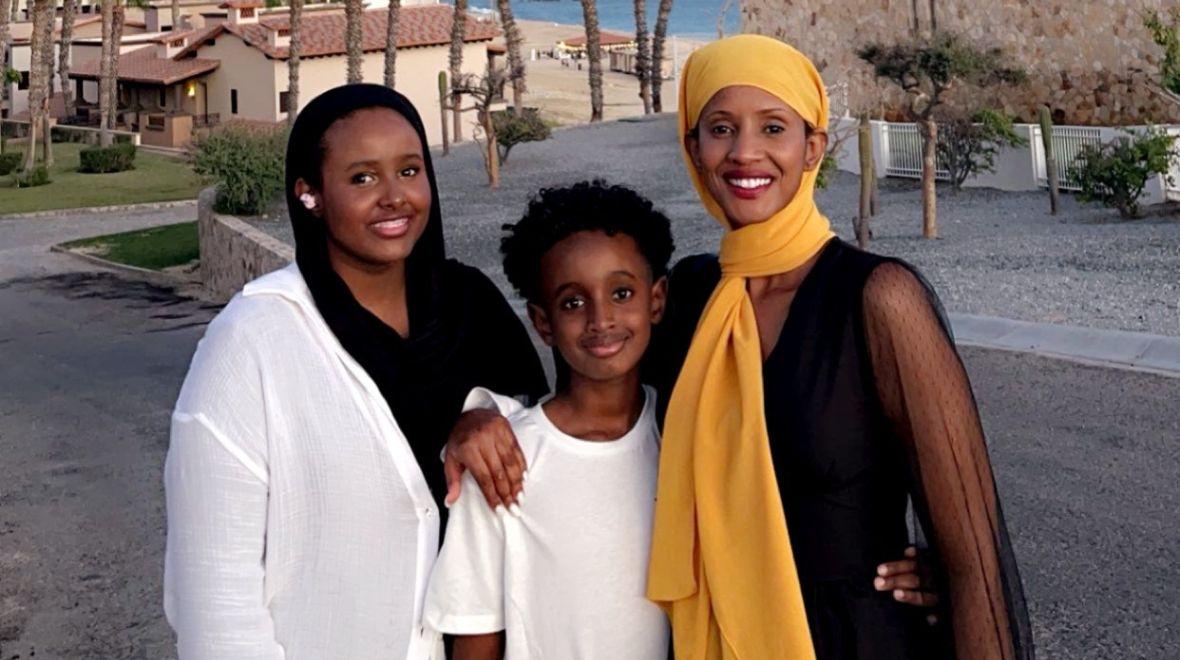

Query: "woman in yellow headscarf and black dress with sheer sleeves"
(648, 35), (1033, 660)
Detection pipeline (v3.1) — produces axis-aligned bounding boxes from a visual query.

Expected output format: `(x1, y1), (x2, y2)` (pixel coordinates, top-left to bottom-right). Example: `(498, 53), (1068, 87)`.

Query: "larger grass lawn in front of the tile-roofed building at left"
(0, 143), (202, 215)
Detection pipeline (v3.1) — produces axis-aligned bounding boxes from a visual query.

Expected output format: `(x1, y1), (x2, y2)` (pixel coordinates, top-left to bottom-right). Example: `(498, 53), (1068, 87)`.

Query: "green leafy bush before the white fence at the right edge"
(1069, 129), (1176, 217)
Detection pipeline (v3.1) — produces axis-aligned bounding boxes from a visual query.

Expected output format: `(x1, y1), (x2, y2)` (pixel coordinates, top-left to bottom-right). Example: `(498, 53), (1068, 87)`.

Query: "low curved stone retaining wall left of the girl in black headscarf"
(197, 188), (295, 301)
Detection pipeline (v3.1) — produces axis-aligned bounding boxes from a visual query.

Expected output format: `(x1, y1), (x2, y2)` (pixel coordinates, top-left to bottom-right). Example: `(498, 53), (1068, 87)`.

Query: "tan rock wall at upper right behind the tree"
(741, 0), (1180, 126)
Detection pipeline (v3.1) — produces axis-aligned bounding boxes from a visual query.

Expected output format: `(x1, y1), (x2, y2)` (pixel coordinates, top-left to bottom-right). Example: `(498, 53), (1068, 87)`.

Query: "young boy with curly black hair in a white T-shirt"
(424, 181), (673, 660)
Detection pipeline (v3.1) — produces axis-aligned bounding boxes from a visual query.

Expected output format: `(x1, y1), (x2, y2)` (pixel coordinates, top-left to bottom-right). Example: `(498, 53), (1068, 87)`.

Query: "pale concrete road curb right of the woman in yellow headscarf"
(949, 314), (1180, 378)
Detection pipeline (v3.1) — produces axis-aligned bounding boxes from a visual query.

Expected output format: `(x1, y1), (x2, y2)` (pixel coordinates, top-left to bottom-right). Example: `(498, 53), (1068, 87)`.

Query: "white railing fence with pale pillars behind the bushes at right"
(833, 117), (1180, 204)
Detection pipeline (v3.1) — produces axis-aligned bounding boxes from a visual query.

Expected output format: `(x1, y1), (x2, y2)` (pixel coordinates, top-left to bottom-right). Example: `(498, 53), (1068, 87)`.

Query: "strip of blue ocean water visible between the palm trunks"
(470, 0), (741, 39)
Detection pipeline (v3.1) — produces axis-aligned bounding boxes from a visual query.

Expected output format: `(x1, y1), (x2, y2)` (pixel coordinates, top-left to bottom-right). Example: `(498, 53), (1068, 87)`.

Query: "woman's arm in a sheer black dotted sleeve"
(864, 263), (1031, 660)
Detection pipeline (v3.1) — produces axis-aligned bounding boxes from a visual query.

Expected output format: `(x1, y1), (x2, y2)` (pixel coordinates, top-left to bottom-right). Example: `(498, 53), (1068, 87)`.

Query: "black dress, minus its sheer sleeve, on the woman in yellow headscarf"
(644, 240), (1031, 660)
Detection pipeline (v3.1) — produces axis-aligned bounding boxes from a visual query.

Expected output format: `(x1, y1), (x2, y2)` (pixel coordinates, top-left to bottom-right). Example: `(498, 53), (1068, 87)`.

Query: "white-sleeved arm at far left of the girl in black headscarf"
(164, 321), (283, 660)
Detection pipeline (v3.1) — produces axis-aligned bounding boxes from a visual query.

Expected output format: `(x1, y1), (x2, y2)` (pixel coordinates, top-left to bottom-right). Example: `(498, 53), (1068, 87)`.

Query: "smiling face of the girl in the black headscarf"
(295, 107), (431, 270)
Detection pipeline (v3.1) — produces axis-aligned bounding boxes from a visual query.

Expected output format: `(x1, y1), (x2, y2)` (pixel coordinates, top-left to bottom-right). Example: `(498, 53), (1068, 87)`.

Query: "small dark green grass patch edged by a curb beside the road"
(61, 221), (201, 270)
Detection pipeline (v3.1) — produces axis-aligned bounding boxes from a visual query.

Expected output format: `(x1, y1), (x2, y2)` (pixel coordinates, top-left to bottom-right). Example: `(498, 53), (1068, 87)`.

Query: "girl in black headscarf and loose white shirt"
(165, 85), (546, 660)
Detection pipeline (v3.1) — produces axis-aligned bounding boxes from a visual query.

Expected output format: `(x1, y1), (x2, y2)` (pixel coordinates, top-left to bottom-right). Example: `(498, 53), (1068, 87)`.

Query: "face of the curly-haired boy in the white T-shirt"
(529, 231), (667, 381)
